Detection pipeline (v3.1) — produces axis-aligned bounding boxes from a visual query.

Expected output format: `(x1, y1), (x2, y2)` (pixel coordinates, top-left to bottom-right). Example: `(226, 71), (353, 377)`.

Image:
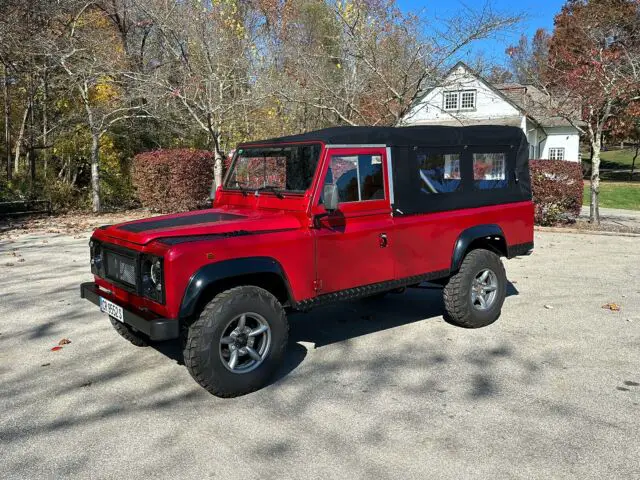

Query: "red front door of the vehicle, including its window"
(312, 147), (395, 295)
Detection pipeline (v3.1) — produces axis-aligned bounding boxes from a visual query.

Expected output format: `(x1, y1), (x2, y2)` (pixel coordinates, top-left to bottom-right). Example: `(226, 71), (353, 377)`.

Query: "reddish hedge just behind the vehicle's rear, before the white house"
(529, 160), (584, 225)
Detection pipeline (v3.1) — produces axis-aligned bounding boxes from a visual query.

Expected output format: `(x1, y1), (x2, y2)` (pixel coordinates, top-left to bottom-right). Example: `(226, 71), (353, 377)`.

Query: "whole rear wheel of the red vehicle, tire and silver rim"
(444, 249), (507, 328)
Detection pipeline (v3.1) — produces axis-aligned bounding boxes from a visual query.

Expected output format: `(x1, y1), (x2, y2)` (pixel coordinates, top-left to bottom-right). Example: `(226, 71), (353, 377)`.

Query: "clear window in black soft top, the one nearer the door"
(417, 151), (462, 195)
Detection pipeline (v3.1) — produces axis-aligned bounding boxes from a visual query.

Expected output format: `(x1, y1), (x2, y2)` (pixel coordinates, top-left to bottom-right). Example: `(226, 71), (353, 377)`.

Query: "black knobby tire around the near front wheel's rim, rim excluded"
(183, 286), (289, 398)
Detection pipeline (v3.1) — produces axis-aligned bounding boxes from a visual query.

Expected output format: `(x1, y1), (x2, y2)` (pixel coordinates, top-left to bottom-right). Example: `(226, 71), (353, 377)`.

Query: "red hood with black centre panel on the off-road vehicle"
(100, 209), (301, 245)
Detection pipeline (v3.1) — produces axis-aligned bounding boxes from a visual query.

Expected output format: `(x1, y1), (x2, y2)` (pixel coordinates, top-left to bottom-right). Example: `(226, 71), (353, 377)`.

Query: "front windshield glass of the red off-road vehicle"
(225, 144), (320, 193)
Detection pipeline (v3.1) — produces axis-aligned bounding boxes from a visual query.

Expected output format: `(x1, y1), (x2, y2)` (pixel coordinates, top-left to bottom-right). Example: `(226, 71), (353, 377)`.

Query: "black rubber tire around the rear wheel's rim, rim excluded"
(443, 249), (507, 328)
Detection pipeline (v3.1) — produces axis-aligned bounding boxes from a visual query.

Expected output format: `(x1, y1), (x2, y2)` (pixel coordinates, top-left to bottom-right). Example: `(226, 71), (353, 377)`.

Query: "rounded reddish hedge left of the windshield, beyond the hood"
(133, 149), (213, 213)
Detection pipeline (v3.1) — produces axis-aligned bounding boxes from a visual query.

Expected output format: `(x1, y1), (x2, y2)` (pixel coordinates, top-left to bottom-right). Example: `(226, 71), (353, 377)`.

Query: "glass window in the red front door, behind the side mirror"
(321, 155), (384, 203)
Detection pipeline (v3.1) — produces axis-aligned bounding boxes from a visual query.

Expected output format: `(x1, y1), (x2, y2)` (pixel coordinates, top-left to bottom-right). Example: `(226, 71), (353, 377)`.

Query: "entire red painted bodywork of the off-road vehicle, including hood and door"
(86, 142), (533, 318)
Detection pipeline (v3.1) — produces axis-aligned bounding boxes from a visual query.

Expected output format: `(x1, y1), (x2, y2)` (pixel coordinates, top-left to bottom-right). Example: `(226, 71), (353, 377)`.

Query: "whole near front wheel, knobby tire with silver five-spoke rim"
(184, 286), (289, 397)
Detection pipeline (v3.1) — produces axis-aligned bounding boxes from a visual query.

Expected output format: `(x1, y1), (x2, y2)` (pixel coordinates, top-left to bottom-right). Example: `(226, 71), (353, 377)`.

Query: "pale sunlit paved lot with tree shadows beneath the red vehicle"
(0, 228), (640, 480)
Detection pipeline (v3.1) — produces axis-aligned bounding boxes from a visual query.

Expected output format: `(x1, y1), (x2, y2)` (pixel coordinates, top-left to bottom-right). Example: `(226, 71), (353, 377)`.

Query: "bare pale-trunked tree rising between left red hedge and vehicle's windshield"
(134, 1), (260, 184)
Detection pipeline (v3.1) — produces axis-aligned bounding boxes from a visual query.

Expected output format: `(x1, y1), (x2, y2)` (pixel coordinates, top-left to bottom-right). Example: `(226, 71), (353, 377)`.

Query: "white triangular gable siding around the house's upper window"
(401, 66), (520, 125)
